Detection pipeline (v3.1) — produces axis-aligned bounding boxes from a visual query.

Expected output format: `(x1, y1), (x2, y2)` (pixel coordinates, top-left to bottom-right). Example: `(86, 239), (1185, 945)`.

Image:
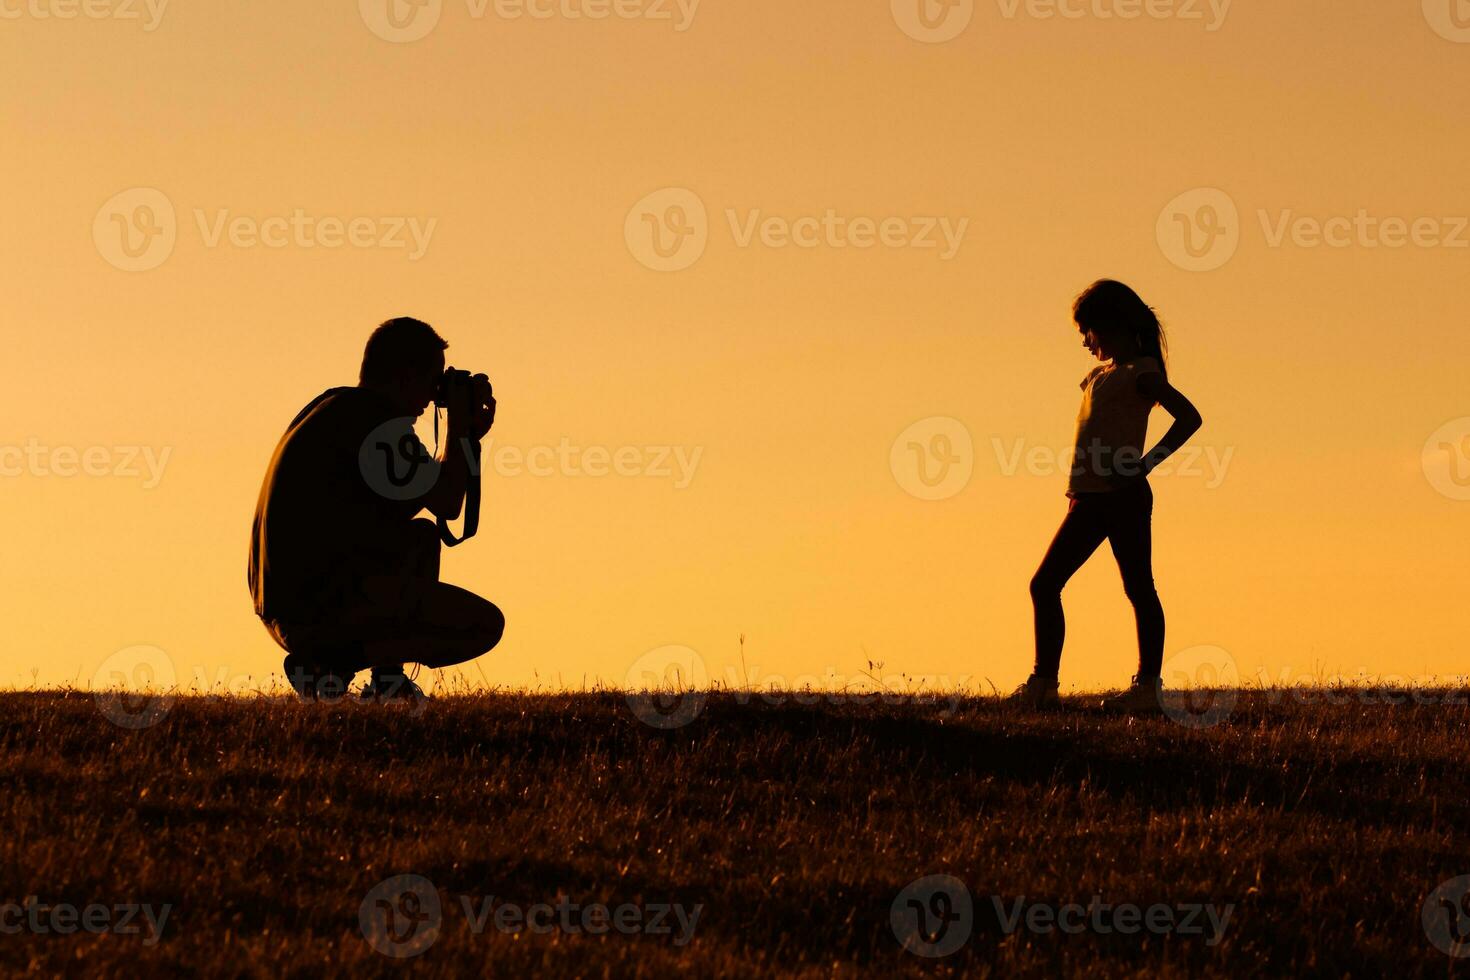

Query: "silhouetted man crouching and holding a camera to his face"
(248, 317), (506, 699)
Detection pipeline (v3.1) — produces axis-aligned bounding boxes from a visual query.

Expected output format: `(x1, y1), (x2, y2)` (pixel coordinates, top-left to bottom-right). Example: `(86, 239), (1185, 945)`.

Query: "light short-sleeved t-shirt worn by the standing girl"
(1067, 357), (1163, 497)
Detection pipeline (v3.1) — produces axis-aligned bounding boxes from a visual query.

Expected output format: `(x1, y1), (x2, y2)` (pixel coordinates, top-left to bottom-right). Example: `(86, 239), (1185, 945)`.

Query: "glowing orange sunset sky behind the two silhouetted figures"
(0, 0), (1470, 688)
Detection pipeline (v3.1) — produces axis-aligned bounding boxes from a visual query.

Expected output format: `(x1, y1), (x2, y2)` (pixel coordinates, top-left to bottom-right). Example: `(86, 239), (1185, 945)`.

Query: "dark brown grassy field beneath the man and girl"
(0, 691), (1470, 977)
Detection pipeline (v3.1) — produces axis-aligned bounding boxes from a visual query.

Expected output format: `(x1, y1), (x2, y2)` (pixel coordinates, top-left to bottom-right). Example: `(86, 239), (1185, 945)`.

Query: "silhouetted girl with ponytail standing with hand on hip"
(1011, 279), (1201, 711)
